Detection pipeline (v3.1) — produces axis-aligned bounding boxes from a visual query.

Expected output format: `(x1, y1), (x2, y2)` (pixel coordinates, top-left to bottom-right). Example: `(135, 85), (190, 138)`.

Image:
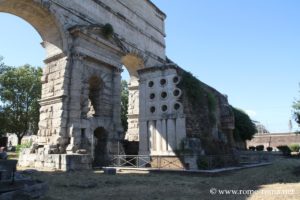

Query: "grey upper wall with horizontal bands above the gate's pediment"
(53, 0), (166, 66)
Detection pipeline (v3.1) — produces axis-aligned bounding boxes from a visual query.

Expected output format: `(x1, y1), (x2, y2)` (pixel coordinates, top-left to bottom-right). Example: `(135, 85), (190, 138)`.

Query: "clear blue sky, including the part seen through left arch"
(0, 0), (300, 132)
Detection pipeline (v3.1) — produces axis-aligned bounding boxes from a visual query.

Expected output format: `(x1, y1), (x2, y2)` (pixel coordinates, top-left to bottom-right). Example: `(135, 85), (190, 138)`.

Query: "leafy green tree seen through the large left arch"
(0, 65), (42, 144)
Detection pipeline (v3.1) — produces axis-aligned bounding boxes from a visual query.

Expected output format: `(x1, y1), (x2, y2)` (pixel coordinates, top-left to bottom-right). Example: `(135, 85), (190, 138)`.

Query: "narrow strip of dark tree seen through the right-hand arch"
(121, 80), (129, 132)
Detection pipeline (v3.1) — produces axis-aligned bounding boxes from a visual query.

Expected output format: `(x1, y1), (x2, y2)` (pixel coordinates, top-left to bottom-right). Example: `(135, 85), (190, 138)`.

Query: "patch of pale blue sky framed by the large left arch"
(0, 12), (45, 67)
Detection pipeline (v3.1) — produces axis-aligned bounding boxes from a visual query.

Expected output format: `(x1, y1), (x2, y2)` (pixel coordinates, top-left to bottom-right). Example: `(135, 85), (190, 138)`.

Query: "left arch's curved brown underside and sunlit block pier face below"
(0, 0), (70, 152)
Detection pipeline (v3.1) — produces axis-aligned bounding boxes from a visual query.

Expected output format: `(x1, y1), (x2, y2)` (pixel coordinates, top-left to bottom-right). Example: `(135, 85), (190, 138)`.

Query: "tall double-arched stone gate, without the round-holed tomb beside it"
(0, 0), (165, 170)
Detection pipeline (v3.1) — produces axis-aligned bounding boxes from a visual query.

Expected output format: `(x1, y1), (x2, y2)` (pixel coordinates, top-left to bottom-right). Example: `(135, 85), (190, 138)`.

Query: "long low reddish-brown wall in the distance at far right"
(247, 133), (300, 148)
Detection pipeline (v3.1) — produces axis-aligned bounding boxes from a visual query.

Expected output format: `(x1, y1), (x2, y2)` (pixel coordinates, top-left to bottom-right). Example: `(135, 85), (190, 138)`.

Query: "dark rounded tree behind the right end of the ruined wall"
(232, 107), (257, 141)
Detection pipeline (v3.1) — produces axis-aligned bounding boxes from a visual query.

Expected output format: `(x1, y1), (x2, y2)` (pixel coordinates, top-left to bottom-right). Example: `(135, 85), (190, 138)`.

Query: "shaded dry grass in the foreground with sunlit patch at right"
(24, 159), (300, 200)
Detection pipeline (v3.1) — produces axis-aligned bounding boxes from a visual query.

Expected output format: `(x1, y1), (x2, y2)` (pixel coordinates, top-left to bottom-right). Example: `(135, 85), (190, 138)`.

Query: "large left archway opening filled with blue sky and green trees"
(0, 12), (45, 146)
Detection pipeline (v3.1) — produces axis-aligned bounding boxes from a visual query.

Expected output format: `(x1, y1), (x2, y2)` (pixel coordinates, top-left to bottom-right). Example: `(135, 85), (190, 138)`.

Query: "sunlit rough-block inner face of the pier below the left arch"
(38, 57), (68, 144)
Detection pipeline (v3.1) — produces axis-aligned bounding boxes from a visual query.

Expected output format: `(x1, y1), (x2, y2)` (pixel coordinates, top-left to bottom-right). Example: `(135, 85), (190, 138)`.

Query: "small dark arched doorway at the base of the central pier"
(93, 127), (109, 167)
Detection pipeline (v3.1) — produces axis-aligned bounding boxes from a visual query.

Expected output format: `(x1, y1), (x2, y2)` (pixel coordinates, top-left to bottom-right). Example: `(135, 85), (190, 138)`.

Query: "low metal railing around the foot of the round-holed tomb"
(111, 152), (272, 170)
